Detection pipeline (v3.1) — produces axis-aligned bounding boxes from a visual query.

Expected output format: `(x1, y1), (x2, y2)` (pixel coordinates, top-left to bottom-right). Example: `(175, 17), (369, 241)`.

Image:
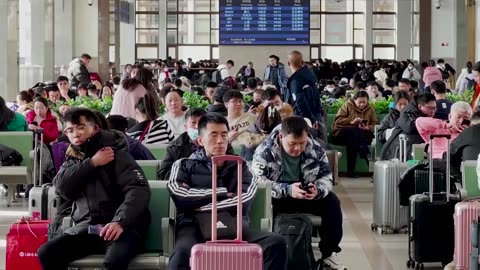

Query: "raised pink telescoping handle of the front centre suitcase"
(212, 155), (243, 242)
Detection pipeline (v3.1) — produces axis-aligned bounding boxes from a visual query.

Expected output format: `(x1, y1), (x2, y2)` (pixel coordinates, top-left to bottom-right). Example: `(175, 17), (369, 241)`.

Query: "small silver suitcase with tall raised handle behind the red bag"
(28, 130), (58, 220)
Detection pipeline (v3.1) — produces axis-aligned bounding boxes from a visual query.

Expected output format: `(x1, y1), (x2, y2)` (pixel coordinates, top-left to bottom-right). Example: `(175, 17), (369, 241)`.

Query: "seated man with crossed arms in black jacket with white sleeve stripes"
(167, 113), (287, 270)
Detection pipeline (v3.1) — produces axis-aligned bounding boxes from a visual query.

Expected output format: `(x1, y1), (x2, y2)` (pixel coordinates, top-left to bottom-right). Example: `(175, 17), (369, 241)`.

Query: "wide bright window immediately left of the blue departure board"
(164, 0), (219, 61)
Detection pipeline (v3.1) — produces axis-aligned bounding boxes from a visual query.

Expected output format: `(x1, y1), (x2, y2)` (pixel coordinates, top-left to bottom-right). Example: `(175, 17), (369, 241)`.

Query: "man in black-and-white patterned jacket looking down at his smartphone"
(252, 116), (343, 269)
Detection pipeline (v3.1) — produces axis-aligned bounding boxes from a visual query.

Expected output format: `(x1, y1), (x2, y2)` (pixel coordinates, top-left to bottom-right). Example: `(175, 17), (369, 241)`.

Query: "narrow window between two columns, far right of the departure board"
(372, 0), (397, 59)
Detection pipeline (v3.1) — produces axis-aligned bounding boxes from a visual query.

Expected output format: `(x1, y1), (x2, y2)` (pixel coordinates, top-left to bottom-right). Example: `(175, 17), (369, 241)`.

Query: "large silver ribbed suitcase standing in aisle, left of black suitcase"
(372, 134), (408, 234)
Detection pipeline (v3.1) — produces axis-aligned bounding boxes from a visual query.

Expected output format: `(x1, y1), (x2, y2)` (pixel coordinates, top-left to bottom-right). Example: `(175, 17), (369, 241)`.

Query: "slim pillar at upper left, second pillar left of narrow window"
(98, 1), (110, 81)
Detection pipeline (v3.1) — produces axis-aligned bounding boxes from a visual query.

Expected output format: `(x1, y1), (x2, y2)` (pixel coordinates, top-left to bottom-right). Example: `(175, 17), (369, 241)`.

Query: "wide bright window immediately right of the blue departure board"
(310, 0), (370, 61)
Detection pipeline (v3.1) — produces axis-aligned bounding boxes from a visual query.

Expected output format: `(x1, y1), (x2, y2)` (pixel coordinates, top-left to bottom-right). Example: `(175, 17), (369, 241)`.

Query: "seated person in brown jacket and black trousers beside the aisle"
(332, 91), (377, 178)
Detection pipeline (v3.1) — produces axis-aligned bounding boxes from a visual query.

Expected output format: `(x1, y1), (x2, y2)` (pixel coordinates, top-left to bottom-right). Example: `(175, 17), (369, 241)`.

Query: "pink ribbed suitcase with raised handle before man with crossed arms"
(190, 156), (263, 270)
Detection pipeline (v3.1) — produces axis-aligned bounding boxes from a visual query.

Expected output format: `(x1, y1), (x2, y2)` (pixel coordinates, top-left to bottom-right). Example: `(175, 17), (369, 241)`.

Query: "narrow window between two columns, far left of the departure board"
(135, 0), (160, 60)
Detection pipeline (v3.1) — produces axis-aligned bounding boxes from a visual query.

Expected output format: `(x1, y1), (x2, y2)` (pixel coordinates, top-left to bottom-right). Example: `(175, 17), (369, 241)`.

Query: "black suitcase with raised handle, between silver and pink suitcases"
(407, 134), (460, 269)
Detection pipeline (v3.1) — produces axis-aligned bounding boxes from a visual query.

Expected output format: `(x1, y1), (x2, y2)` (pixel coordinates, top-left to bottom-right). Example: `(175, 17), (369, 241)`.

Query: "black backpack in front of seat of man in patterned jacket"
(273, 214), (316, 270)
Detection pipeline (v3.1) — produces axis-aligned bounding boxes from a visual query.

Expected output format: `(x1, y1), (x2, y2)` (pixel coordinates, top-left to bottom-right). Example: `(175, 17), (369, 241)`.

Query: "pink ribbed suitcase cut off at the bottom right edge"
(453, 197), (480, 270)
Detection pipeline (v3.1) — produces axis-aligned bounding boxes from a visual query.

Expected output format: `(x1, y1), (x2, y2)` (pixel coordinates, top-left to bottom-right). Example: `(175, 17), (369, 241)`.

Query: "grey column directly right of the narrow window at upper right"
(395, 1), (413, 59)
